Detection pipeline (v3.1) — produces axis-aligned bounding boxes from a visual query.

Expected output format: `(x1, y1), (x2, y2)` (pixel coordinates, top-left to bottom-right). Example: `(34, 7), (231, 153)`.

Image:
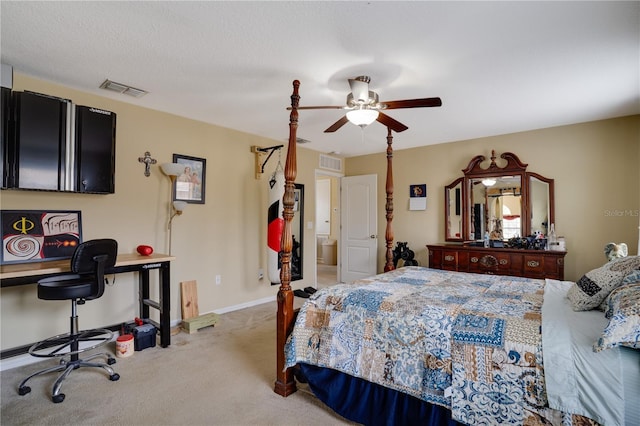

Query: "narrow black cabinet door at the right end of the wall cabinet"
(76, 106), (116, 194)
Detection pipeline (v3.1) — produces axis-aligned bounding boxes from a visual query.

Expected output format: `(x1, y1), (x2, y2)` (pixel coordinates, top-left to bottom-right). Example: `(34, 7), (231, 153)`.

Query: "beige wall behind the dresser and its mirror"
(346, 116), (640, 280)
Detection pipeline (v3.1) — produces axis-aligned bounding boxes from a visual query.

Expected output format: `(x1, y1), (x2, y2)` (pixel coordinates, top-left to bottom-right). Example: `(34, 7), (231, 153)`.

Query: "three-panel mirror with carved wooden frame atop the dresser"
(445, 151), (554, 242)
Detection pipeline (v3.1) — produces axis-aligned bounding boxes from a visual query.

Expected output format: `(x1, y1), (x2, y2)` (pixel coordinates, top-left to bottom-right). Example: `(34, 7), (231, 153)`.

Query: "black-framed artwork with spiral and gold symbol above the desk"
(0, 210), (82, 264)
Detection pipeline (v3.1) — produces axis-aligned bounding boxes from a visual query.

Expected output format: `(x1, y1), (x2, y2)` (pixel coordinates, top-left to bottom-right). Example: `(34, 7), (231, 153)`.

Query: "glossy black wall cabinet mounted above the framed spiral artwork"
(6, 92), (116, 194)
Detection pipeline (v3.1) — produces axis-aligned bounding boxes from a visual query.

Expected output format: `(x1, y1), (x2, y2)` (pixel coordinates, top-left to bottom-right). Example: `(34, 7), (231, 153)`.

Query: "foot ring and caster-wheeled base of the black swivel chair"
(18, 329), (120, 403)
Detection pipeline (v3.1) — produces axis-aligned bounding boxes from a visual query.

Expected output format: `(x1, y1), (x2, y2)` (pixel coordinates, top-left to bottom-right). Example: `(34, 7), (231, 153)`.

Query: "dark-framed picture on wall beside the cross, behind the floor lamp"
(173, 154), (207, 204)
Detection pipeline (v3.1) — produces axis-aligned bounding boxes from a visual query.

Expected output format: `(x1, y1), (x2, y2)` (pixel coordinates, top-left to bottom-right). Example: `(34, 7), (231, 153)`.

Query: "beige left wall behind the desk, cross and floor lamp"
(0, 74), (319, 350)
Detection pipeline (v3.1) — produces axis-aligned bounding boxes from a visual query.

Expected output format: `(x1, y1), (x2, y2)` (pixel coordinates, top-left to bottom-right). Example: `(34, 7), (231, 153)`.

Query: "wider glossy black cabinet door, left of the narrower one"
(14, 92), (67, 190)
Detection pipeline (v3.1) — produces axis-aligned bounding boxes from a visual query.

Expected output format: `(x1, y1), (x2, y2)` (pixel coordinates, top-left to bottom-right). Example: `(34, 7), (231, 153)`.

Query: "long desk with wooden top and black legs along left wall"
(0, 254), (175, 348)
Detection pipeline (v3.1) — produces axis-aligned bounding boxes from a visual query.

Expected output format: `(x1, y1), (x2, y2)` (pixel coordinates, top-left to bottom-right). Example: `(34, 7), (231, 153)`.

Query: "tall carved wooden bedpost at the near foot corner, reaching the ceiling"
(274, 80), (300, 396)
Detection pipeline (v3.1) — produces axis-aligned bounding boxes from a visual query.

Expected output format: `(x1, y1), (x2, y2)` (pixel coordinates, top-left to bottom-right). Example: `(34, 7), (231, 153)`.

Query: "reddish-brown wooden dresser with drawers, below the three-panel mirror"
(427, 244), (567, 280)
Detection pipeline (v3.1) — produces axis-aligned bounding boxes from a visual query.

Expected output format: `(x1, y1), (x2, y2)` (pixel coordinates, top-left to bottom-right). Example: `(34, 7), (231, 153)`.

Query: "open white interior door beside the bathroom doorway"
(340, 175), (378, 282)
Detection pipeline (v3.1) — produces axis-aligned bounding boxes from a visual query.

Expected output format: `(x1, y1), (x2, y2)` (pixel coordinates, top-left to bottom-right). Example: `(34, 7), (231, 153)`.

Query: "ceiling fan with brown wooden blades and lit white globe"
(287, 75), (442, 133)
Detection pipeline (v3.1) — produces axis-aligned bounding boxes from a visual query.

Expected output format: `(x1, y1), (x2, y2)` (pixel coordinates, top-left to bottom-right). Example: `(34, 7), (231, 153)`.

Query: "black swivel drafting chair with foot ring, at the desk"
(18, 239), (120, 402)
